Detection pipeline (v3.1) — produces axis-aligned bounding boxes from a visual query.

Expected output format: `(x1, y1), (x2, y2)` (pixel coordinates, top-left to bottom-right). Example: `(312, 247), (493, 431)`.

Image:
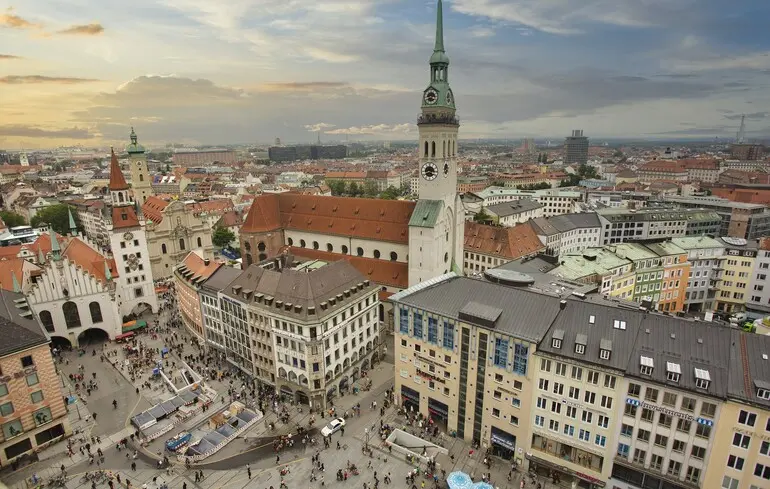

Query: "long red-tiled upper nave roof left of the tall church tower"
(241, 193), (415, 243)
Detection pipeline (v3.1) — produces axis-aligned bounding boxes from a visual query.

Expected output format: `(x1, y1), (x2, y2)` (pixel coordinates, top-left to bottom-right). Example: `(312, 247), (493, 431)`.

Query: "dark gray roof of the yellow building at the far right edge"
(728, 329), (770, 409)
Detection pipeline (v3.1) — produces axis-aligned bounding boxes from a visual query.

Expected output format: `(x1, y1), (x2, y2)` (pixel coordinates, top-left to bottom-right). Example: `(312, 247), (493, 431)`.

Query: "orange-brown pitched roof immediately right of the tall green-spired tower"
(465, 221), (545, 260)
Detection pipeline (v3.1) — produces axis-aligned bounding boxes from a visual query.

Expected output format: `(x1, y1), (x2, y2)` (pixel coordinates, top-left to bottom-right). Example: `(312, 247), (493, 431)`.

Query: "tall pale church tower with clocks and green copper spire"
(409, 0), (465, 286)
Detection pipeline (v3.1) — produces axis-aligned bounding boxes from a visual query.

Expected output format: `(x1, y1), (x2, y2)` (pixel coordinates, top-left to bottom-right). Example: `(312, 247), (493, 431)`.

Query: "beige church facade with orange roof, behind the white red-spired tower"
(142, 196), (214, 280)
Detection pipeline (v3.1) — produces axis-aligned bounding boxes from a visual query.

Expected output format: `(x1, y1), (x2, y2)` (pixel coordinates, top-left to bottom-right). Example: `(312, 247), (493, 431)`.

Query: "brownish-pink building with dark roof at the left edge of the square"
(0, 291), (72, 467)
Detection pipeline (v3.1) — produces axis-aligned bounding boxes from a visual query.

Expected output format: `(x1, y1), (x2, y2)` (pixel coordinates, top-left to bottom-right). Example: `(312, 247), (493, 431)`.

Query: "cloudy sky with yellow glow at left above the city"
(0, 0), (770, 149)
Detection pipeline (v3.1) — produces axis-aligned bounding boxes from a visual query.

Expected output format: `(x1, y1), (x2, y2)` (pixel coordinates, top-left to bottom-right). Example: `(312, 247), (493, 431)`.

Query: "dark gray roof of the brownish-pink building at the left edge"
(0, 290), (48, 357)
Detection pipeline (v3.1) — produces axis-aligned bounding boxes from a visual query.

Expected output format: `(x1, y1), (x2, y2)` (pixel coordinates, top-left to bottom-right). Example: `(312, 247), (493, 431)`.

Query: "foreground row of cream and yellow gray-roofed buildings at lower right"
(391, 266), (770, 489)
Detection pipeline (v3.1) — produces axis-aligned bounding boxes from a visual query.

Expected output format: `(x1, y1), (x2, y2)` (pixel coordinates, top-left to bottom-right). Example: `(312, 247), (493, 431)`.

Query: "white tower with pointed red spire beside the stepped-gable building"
(106, 147), (158, 316)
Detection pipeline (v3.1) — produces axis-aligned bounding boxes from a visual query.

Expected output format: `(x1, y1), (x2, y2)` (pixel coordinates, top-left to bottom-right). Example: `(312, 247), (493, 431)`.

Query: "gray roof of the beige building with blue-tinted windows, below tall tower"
(395, 277), (559, 343)
